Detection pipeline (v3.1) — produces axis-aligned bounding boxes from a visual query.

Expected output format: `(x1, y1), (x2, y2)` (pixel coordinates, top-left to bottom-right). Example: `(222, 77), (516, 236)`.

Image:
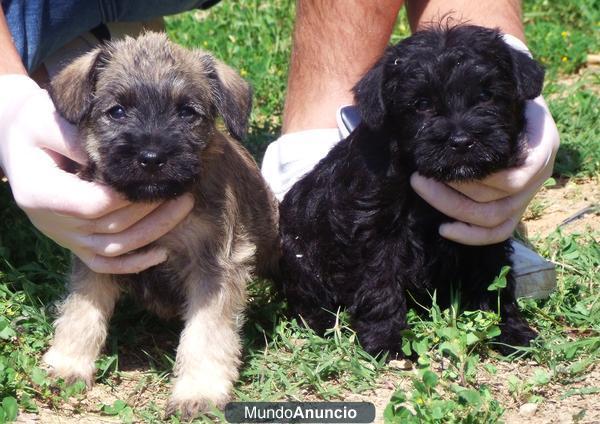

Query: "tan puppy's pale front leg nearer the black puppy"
(167, 273), (246, 419)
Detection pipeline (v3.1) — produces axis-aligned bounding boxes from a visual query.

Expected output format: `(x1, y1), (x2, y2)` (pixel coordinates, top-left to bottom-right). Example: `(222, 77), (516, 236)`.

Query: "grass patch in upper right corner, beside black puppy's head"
(524, 0), (600, 177)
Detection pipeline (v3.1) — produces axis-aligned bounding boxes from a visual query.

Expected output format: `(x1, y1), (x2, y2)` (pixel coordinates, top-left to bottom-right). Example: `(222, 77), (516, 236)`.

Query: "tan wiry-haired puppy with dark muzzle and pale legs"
(44, 33), (277, 418)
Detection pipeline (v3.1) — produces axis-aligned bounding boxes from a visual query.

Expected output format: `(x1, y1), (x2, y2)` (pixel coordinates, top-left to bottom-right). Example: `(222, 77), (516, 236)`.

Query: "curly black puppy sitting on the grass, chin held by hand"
(280, 25), (544, 355)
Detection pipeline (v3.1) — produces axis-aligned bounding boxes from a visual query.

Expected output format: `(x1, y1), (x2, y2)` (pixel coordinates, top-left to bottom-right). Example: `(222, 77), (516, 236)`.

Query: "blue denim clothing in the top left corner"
(1, 0), (218, 72)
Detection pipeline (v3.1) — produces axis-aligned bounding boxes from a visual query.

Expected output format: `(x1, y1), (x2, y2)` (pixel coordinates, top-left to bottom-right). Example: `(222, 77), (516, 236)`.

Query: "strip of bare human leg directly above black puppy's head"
(406, 0), (525, 41)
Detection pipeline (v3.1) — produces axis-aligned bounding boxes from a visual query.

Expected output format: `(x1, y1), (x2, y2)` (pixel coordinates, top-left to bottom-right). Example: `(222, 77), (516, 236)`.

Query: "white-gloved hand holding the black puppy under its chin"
(411, 96), (559, 245)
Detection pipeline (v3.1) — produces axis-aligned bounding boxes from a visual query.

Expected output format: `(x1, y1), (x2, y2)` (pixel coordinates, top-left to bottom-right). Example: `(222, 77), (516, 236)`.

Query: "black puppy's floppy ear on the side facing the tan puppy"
(352, 55), (386, 129)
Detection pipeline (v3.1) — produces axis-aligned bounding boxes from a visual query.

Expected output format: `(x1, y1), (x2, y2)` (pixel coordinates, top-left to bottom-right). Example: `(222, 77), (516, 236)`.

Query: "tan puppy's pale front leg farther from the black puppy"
(43, 265), (120, 387)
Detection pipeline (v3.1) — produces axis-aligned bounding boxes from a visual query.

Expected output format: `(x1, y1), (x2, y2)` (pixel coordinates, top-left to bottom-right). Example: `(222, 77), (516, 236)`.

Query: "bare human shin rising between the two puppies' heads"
(283, 0), (402, 133)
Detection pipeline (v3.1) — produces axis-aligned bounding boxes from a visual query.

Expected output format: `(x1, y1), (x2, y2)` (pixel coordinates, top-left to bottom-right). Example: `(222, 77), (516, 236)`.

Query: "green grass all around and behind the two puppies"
(0, 0), (600, 423)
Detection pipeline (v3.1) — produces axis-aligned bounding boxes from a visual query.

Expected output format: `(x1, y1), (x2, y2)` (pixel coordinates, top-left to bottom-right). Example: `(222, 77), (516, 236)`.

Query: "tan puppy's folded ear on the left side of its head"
(49, 46), (110, 124)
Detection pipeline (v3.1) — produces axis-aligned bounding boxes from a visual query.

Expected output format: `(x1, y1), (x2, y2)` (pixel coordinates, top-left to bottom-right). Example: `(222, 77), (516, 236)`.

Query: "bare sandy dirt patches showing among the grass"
(18, 178), (600, 424)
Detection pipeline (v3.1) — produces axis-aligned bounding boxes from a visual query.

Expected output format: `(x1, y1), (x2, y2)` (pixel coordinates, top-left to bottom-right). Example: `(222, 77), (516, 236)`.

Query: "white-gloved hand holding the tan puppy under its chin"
(0, 75), (193, 274)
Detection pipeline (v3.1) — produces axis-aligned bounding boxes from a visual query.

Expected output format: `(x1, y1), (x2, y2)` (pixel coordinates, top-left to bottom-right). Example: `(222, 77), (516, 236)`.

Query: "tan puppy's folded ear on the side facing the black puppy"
(205, 56), (252, 140)
